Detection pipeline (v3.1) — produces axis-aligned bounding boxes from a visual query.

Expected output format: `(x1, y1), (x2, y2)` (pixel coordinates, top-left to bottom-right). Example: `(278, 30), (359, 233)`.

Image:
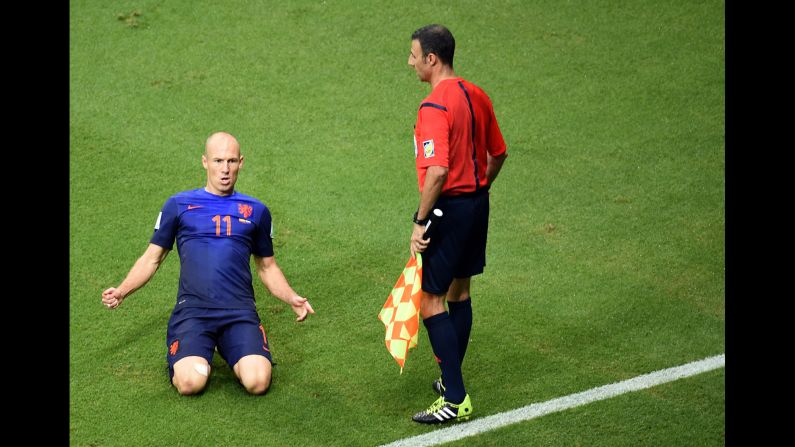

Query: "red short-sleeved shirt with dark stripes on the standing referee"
(414, 78), (506, 195)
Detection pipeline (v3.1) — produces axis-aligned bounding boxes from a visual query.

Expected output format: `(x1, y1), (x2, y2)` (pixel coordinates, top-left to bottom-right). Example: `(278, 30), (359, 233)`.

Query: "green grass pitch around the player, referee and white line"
(69, 0), (725, 446)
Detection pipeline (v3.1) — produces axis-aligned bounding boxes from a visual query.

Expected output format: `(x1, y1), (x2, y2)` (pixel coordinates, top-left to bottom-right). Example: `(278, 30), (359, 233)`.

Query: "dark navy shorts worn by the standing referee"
(422, 188), (489, 295)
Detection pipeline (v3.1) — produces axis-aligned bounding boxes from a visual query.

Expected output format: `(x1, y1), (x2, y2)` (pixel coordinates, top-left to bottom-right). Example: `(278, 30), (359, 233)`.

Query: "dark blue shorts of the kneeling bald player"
(166, 307), (273, 378)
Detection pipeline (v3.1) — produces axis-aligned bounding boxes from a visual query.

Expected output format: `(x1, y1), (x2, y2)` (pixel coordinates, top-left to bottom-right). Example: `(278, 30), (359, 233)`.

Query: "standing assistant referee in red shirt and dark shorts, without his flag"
(408, 24), (508, 423)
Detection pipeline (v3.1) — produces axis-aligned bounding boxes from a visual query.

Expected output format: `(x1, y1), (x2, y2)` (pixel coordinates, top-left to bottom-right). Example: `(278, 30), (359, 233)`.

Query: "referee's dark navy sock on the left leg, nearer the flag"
(422, 312), (466, 404)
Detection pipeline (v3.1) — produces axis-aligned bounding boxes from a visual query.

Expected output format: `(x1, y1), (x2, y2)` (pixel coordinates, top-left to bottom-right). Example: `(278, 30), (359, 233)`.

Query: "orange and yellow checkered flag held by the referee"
(378, 253), (422, 374)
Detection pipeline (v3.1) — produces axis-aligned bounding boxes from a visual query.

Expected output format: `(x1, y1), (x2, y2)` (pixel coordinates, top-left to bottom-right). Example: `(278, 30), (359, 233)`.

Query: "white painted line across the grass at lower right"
(381, 354), (726, 447)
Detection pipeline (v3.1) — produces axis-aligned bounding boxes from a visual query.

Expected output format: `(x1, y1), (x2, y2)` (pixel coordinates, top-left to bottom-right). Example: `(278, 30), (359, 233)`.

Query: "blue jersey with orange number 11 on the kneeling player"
(150, 188), (273, 309)
